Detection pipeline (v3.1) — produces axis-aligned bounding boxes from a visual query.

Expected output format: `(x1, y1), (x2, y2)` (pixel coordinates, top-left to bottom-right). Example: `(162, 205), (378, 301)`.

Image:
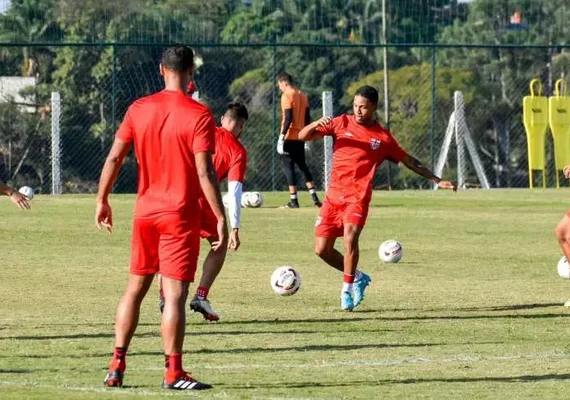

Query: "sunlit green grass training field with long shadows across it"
(0, 190), (570, 399)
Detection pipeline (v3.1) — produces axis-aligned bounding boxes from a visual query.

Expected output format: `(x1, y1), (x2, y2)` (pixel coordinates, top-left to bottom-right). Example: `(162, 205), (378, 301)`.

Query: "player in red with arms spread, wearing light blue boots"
(299, 86), (457, 311)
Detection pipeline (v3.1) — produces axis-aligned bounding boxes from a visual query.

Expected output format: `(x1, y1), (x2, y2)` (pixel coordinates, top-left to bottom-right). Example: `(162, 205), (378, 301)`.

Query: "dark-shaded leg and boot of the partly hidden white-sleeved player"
(190, 235), (228, 321)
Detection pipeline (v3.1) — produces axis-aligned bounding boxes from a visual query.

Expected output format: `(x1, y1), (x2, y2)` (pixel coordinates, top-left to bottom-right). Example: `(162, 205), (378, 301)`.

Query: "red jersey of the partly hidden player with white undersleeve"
(213, 128), (247, 183)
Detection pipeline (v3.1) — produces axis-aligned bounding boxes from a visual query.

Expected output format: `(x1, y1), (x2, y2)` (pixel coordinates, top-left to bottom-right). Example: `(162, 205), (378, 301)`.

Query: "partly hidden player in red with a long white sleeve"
(159, 103), (249, 321)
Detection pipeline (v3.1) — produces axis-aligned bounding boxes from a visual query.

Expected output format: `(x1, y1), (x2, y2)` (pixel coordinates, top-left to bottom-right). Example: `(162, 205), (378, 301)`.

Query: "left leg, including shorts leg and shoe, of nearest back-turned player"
(104, 220), (158, 386)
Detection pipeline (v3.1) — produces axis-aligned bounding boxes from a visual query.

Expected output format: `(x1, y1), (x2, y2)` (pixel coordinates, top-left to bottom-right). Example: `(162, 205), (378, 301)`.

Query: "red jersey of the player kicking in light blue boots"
(316, 115), (406, 203)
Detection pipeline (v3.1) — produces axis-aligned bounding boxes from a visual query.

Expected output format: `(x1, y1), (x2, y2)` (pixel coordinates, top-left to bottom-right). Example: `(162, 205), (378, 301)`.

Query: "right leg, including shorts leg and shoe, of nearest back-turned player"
(158, 214), (211, 390)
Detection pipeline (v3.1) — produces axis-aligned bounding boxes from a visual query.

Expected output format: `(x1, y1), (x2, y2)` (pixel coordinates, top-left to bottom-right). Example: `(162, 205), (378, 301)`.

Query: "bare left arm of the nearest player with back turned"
(95, 139), (132, 233)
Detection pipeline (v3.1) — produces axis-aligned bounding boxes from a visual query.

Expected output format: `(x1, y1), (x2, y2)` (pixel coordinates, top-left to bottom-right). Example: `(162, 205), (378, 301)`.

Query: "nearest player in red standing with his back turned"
(95, 46), (224, 390)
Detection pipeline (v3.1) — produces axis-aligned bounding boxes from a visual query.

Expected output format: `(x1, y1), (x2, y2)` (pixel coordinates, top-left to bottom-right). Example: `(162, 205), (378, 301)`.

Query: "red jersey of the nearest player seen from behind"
(117, 90), (216, 218)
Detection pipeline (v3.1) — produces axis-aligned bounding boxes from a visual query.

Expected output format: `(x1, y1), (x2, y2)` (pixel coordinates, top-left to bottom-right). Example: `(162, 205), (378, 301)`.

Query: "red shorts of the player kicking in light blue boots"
(315, 197), (369, 238)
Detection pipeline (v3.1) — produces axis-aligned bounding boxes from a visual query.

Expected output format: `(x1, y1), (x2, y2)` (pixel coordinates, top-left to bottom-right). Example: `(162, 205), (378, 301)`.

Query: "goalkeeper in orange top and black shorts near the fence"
(277, 72), (322, 208)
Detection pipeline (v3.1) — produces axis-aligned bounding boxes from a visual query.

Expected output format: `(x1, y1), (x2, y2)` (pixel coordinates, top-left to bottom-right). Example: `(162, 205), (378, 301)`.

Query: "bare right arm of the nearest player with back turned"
(195, 151), (228, 251)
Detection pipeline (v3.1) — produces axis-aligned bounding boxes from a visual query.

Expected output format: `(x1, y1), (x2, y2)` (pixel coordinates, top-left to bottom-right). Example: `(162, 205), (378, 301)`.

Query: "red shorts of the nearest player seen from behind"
(131, 214), (200, 282)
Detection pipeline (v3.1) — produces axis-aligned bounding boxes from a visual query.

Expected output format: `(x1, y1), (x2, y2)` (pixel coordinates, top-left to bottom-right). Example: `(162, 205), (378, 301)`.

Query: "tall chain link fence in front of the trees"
(0, 42), (570, 193)
